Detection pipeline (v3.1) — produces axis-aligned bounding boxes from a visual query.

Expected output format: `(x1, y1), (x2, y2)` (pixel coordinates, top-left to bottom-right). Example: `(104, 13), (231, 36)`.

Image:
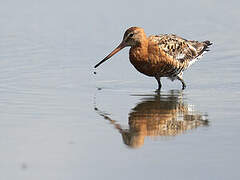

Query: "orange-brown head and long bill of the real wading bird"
(94, 27), (146, 68)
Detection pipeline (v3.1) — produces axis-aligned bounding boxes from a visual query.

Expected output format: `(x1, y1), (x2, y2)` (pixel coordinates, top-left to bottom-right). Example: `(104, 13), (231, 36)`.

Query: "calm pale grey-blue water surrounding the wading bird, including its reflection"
(0, 0), (240, 180)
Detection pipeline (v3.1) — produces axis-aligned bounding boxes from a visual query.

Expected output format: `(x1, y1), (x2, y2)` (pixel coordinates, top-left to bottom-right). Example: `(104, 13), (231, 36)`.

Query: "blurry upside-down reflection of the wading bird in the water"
(95, 91), (208, 148)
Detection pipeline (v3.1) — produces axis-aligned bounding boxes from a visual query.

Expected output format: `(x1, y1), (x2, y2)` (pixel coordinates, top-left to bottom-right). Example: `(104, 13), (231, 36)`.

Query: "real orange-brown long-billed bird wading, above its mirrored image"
(94, 27), (212, 91)
